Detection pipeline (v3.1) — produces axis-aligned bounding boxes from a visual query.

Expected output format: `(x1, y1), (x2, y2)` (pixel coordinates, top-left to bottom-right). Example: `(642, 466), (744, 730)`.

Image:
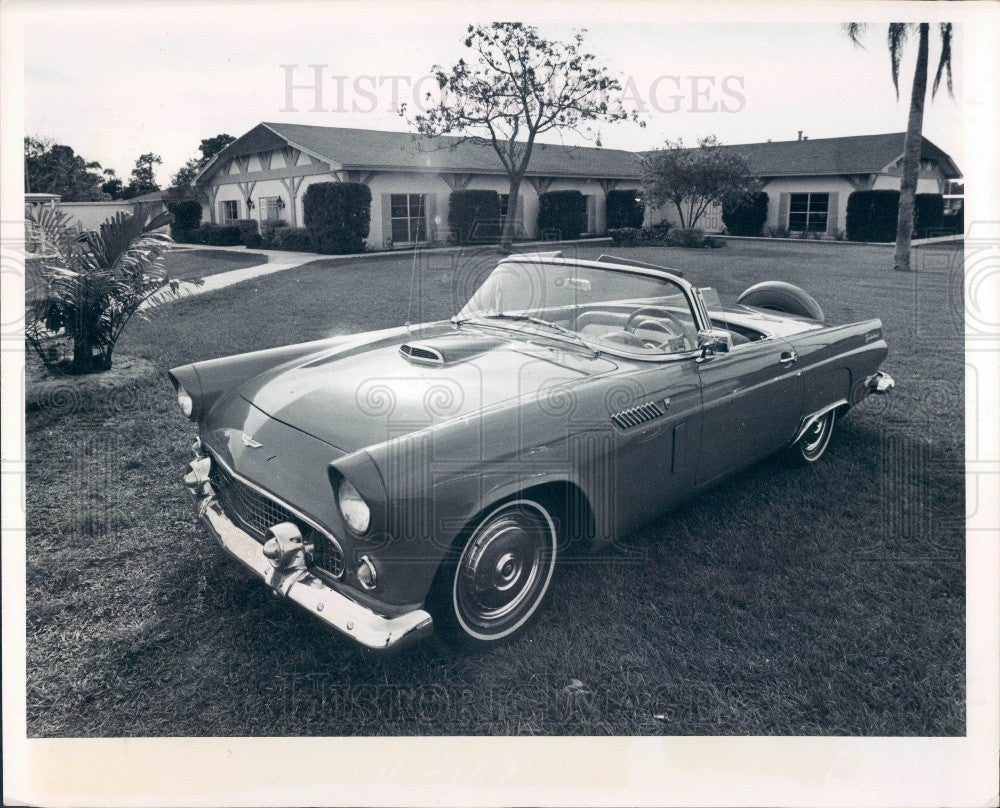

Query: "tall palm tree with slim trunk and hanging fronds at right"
(844, 22), (954, 272)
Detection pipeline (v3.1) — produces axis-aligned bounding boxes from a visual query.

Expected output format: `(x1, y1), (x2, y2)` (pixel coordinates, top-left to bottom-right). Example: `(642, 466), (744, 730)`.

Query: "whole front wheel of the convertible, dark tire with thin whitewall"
(432, 499), (558, 647)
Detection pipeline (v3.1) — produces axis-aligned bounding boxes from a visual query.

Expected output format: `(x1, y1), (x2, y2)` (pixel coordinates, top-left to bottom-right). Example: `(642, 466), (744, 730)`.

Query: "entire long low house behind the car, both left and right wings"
(195, 123), (961, 249)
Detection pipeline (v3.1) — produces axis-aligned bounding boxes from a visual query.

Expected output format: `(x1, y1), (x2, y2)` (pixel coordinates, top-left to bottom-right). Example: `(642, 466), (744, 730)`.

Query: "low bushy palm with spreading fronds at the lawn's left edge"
(25, 206), (179, 374)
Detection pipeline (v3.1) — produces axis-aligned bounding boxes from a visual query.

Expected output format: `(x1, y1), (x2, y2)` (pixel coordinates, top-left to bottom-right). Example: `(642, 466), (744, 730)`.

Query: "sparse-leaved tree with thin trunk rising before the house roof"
(408, 22), (637, 252)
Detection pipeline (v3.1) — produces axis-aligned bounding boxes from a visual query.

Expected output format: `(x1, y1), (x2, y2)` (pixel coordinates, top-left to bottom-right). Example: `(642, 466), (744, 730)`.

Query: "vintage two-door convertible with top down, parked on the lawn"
(170, 253), (893, 649)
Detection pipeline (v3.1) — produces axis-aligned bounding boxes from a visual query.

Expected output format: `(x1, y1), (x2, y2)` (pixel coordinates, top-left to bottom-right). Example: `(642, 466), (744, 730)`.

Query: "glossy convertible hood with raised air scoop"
(228, 327), (616, 452)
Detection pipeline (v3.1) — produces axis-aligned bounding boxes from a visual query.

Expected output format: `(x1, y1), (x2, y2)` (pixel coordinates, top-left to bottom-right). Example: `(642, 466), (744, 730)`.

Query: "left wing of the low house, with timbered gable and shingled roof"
(195, 123), (642, 249)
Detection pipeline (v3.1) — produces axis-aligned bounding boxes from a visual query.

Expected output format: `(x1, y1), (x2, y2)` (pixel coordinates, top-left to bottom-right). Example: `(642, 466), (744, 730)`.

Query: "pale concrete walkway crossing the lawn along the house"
(151, 238), (611, 308)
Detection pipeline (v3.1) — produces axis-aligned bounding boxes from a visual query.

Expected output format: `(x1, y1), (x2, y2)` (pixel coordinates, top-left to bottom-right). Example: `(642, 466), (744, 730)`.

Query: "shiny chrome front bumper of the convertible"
(184, 441), (432, 650)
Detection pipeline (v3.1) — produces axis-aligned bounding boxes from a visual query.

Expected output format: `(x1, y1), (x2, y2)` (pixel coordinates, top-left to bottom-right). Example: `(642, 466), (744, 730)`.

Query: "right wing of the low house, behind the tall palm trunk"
(652, 132), (962, 236)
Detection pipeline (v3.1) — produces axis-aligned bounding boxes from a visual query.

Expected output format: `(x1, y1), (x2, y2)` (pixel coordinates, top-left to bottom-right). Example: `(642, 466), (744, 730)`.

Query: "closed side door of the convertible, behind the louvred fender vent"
(697, 338), (803, 485)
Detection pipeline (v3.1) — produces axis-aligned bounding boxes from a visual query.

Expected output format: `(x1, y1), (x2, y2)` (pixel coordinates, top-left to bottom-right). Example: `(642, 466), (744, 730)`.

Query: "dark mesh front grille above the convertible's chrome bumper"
(209, 457), (344, 578)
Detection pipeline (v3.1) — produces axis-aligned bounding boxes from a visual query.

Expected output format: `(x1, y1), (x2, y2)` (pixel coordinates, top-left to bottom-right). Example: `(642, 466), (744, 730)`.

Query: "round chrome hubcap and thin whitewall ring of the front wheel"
(454, 508), (555, 638)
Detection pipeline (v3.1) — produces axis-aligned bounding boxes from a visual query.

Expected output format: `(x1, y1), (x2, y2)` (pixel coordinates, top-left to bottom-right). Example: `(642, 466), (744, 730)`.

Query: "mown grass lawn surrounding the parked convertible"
(27, 237), (965, 736)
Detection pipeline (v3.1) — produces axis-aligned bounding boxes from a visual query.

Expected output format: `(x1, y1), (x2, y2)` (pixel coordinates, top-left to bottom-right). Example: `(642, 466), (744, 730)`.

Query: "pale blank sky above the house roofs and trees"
(25, 3), (964, 185)
